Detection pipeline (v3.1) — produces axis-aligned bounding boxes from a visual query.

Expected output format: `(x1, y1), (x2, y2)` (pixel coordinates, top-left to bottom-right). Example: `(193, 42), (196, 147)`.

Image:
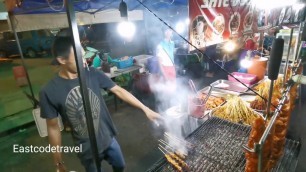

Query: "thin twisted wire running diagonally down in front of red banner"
(137, 0), (277, 108)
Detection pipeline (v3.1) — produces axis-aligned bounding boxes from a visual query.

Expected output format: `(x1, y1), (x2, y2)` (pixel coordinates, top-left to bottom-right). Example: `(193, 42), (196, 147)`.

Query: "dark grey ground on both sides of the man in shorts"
(0, 103), (162, 172)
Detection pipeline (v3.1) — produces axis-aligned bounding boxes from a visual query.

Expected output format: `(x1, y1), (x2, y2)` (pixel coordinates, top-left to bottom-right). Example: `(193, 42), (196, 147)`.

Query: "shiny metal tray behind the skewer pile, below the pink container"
(210, 79), (248, 95)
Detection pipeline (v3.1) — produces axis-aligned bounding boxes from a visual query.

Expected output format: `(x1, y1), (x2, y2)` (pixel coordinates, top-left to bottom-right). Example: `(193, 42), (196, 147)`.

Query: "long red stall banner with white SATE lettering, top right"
(189, 0), (305, 51)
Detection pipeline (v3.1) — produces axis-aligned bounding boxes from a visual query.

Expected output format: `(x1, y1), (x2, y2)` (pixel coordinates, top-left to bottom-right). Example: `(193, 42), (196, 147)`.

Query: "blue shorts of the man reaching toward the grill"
(81, 138), (125, 172)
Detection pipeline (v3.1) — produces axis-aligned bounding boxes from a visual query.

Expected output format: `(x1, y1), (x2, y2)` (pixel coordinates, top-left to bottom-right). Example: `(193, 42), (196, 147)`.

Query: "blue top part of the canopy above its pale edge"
(13, 0), (188, 15)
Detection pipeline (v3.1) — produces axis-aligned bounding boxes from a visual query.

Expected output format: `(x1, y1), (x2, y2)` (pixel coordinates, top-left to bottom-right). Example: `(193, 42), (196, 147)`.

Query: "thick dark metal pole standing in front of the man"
(65, 0), (101, 172)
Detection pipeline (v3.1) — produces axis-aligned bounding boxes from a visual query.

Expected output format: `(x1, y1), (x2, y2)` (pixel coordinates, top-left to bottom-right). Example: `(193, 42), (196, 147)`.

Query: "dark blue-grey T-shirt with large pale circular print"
(39, 67), (117, 159)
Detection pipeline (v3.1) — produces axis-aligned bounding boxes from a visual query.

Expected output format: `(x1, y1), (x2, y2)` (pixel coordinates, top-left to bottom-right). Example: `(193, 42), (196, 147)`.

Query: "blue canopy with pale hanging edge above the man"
(1, 0), (188, 32)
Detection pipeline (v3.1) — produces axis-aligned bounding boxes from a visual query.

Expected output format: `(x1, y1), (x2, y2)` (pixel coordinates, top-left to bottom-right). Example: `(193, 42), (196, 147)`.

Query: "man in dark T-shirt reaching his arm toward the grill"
(39, 37), (160, 172)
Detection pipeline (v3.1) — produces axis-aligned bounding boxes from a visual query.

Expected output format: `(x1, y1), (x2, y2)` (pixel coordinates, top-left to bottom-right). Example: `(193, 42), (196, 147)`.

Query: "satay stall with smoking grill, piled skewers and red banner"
(148, 0), (305, 172)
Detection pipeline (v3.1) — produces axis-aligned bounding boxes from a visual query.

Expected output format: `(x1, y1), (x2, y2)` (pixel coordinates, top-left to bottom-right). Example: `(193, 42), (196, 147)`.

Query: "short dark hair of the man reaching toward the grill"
(52, 36), (73, 58)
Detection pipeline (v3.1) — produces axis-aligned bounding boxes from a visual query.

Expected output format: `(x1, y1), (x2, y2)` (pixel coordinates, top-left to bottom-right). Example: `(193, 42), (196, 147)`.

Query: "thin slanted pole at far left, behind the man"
(8, 12), (38, 109)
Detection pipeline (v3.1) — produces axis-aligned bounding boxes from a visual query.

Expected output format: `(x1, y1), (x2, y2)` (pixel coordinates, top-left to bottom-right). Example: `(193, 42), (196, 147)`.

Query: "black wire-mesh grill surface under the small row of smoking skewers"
(147, 117), (300, 172)
